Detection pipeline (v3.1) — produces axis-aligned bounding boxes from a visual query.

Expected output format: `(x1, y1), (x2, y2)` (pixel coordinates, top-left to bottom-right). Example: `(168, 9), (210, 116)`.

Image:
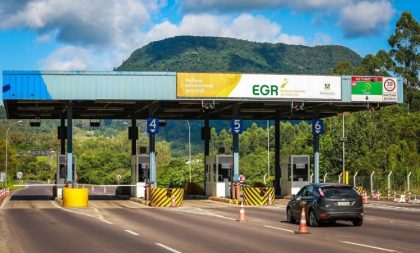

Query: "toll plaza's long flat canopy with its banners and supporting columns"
(3, 71), (403, 206)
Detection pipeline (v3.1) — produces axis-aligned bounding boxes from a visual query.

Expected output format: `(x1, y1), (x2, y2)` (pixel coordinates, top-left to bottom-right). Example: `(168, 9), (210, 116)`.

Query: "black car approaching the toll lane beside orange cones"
(286, 183), (363, 227)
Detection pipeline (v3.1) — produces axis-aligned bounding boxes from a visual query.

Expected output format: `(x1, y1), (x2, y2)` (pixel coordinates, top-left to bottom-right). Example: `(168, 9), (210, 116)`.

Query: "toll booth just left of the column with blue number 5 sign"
(206, 155), (233, 198)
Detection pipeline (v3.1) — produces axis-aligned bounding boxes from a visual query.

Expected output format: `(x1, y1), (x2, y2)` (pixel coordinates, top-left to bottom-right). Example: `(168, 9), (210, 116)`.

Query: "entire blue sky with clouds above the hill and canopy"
(0, 0), (420, 74)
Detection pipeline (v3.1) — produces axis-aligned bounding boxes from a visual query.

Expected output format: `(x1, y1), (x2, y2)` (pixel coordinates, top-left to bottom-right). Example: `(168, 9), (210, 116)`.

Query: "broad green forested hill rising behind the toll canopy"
(116, 36), (361, 74)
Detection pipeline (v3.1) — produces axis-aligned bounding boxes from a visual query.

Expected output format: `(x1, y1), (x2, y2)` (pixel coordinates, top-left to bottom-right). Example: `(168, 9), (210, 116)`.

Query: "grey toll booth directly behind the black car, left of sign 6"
(280, 155), (311, 195)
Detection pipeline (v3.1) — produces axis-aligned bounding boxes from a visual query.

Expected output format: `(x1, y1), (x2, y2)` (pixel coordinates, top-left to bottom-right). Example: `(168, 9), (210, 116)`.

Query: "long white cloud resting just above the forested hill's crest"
(145, 14), (305, 44)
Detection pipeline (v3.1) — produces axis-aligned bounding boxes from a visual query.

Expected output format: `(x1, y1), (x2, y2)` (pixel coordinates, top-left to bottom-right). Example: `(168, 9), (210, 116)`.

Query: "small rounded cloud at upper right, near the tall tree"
(339, 0), (394, 37)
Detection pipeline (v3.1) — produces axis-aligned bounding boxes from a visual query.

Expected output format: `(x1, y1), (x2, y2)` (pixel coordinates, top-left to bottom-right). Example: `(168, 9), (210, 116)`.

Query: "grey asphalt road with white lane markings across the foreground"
(0, 188), (420, 253)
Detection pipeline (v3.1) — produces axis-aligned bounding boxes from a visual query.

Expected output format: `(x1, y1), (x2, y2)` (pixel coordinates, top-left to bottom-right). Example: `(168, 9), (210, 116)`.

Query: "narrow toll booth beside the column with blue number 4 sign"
(131, 154), (150, 198)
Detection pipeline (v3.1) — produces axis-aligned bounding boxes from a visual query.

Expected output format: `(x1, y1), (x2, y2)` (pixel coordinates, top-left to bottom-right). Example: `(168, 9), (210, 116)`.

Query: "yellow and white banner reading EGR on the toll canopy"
(177, 73), (341, 100)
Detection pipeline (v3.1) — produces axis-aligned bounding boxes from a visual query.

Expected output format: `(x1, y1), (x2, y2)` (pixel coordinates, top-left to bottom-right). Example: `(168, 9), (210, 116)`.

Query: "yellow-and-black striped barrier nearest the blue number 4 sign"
(151, 188), (184, 207)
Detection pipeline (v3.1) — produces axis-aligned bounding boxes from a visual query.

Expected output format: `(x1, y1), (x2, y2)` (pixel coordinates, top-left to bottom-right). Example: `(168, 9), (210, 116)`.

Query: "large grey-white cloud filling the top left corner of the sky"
(0, 0), (166, 47)
